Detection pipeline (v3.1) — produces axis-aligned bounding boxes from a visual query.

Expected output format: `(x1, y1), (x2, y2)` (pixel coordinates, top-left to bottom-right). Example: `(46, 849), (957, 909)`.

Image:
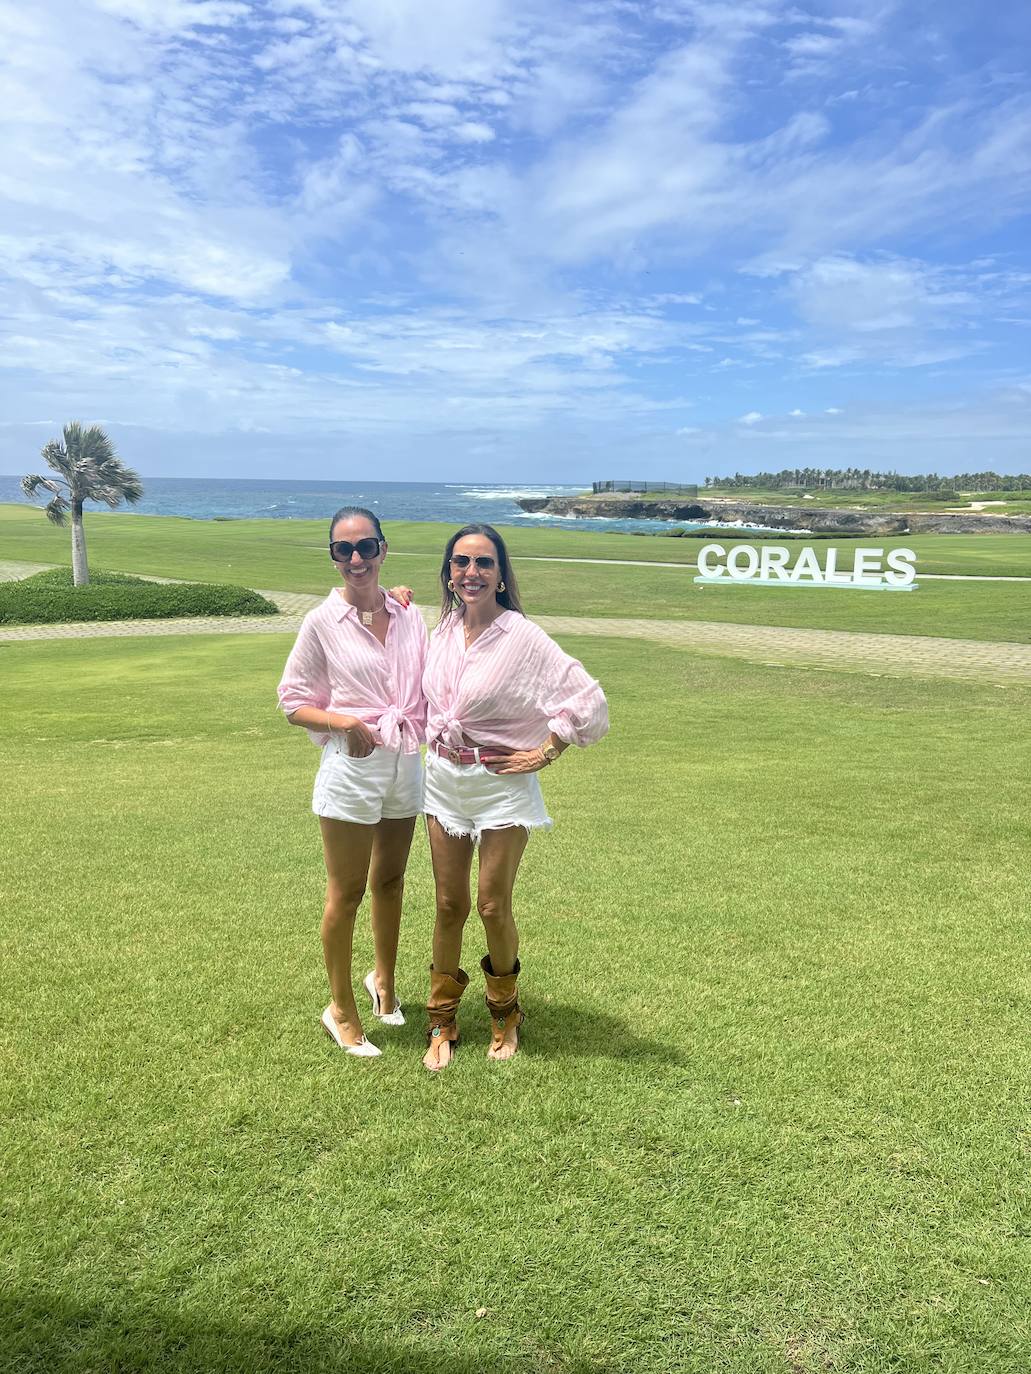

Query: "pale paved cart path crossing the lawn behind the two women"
(0, 563), (1031, 686)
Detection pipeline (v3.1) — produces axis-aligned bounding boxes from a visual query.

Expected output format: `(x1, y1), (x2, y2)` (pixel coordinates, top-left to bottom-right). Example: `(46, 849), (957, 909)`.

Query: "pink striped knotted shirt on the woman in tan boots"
(422, 610), (609, 749)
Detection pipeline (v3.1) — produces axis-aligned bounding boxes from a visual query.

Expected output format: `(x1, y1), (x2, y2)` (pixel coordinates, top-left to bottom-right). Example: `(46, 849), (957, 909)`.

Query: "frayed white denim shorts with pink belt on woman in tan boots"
(423, 749), (554, 840)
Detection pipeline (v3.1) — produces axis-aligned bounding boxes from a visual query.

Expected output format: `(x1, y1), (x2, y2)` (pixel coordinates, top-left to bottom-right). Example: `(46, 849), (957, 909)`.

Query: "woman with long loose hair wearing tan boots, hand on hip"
(422, 525), (609, 1072)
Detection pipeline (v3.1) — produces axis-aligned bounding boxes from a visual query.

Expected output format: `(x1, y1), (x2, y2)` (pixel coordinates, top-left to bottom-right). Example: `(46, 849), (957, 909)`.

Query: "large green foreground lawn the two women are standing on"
(0, 634), (1031, 1374)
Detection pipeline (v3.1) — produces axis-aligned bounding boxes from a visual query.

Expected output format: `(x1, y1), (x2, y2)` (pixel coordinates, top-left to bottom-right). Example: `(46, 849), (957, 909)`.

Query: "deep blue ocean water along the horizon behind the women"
(0, 477), (720, 533)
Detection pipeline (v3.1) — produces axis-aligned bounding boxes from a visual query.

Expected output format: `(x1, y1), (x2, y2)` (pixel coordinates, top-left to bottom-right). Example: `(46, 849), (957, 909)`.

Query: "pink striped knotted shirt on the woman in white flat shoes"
(279, 587), (426, 754)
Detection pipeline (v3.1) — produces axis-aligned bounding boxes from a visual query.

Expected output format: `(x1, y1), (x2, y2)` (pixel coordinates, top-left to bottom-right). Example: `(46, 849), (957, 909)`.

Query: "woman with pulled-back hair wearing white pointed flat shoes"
(279, 506), (426, 1057)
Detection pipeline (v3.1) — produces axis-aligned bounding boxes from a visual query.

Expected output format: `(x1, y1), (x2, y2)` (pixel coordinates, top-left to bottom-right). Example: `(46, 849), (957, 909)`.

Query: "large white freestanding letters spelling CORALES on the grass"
(694, 544), (918, 592)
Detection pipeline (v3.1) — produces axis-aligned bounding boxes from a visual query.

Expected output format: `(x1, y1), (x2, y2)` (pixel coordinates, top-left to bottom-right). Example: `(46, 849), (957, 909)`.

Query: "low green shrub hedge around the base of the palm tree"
(0, 567), (278, 625)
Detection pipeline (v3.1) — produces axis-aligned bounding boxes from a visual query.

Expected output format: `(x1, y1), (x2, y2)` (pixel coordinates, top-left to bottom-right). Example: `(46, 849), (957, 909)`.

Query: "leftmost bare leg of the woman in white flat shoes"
(319, 816), (375, 1044)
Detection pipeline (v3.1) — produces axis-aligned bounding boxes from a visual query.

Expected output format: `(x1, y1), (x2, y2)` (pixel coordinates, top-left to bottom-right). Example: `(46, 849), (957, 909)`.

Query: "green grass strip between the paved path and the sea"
(0, 506), (1031, 643)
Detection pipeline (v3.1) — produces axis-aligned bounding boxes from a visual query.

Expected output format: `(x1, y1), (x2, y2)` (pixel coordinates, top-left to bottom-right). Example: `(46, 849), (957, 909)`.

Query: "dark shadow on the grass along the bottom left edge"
(0, 1290), (588, 1374)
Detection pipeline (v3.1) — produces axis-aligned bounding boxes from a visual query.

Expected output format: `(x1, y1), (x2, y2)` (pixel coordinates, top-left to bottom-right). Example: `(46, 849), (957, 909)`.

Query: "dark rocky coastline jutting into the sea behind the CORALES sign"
(518, 496), (1031, 534)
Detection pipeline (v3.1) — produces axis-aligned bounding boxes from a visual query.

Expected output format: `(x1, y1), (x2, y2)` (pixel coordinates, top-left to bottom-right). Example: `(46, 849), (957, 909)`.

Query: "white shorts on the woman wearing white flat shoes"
(312, 735), (422, 826)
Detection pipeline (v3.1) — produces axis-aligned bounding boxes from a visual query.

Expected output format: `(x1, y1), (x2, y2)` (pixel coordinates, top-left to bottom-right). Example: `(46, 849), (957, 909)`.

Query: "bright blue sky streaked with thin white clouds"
(0, 0), (1031, 482)
